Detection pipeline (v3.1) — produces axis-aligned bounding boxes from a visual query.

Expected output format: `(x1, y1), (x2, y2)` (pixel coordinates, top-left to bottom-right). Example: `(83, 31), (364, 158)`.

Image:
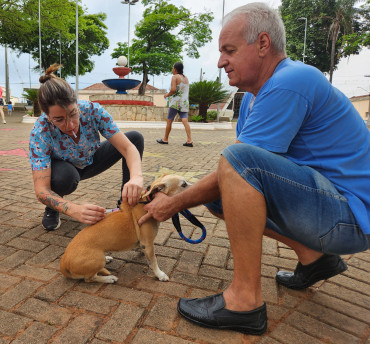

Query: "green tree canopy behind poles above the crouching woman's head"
(0, 0), (109, 77)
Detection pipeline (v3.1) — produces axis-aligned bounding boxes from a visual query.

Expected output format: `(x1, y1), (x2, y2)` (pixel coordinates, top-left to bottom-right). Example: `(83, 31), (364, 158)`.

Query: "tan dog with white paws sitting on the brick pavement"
(60, 175), (190, 283)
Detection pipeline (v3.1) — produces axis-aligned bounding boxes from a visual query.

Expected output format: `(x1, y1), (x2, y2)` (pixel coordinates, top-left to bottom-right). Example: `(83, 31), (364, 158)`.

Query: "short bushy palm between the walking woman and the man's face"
(189, 80), (229, 122)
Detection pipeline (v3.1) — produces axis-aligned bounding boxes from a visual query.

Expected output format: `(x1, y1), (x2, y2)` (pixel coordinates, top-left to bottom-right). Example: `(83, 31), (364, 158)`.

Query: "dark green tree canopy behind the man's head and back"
(280, 0), (369, 79)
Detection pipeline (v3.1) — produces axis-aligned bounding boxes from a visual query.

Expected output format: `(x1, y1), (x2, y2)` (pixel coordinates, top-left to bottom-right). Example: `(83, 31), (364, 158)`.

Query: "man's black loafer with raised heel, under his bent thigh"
(275, 254), (348, 289)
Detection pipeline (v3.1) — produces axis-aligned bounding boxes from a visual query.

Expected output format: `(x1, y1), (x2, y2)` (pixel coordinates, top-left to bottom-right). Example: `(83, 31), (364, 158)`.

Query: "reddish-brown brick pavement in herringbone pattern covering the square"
(0, 113), (370, 344)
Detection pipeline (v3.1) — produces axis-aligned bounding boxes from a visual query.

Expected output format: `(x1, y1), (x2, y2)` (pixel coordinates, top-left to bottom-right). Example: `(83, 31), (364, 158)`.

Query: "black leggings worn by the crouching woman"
(51, 131), (144, 202)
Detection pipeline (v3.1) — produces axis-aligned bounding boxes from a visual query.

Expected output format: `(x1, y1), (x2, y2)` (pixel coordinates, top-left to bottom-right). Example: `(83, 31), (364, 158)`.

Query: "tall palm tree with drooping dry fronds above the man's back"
(324, 0), (358, 82)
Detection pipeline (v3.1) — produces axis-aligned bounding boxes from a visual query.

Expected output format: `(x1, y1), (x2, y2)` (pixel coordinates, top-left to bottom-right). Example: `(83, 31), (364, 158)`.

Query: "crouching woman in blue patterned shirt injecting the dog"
(29, 64), (144, 231)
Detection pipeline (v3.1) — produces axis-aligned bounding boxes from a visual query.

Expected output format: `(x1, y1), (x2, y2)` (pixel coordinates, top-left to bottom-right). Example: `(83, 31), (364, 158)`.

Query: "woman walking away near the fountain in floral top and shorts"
(157, 62), (193, 147)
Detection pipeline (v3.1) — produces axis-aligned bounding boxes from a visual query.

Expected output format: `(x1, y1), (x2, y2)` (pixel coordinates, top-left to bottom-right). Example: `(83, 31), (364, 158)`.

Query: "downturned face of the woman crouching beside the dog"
(48, 103), (80, 137)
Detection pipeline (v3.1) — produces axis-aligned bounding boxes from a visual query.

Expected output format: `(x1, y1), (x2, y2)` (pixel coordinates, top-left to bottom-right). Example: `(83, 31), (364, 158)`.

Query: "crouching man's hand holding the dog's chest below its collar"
(138, 192), (178, 226)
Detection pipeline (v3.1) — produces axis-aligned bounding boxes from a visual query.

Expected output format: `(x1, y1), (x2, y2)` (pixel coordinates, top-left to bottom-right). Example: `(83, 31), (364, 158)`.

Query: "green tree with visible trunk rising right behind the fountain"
(111, 0), (213, 94)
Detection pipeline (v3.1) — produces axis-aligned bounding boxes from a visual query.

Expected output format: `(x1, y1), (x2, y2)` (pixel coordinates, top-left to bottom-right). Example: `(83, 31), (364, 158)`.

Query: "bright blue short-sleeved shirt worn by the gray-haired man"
(237, 58), (370, 234)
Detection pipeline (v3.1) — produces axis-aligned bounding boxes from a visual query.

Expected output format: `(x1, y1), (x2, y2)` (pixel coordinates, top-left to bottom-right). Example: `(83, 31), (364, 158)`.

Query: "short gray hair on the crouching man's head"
(224, 2), (286, 53)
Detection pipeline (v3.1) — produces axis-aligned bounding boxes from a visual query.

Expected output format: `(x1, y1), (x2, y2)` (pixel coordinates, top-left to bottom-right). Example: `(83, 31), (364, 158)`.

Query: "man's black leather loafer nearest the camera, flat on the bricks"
(177, 293), (267, 335)
